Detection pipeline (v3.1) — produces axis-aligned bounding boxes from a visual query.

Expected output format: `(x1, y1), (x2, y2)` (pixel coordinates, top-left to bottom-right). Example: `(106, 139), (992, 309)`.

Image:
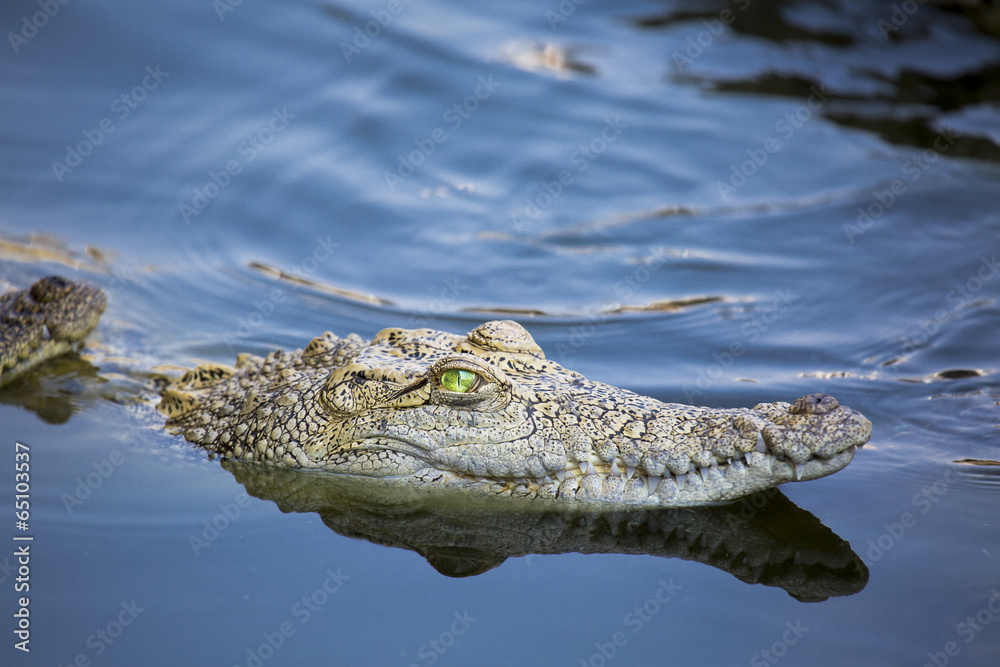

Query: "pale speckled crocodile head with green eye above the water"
(160, 321), (871, 507)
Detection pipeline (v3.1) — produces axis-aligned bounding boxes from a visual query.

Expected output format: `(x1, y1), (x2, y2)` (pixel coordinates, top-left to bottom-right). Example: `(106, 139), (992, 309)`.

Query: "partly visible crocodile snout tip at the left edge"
(0, 276), (107, 385)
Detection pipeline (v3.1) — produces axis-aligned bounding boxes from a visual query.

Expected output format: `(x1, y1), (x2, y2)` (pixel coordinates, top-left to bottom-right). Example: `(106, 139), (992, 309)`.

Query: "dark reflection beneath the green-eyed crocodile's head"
(222, 461), (868, 602)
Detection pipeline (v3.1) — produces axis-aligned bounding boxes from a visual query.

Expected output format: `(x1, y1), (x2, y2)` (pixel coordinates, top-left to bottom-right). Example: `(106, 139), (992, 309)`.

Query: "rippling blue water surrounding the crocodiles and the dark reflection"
(0, 0), (1000, 665)
